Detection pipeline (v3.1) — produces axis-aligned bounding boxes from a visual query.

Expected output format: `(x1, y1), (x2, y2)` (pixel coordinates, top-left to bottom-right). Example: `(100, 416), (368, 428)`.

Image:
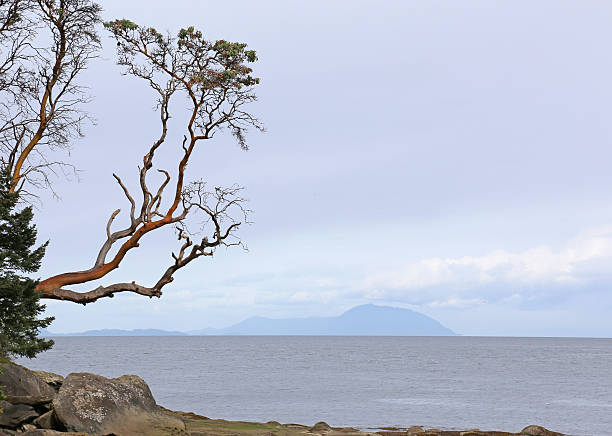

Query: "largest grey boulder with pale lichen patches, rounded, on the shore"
(53, 373), (186, 436)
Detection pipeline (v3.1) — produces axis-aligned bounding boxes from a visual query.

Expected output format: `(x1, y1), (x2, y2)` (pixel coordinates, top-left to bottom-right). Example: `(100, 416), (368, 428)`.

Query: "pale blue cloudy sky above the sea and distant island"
(29, 0), (612, 337)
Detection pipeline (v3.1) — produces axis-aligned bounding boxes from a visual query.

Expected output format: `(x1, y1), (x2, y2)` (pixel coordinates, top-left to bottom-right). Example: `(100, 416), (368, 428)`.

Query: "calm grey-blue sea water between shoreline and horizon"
(15, 336), (612, 435)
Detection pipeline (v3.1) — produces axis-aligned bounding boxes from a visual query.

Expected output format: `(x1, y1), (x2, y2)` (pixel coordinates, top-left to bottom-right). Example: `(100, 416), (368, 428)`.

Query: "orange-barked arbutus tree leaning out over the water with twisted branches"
(36, 20), (263, 304)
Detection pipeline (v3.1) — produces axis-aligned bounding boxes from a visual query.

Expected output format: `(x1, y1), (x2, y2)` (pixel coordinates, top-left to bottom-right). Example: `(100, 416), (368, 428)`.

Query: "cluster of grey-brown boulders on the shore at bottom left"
(0, 363), (187, 436)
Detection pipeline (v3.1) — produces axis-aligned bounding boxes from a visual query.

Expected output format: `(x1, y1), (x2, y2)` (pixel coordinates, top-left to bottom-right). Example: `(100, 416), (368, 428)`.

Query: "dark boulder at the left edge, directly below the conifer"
(0, 363), (55, 401)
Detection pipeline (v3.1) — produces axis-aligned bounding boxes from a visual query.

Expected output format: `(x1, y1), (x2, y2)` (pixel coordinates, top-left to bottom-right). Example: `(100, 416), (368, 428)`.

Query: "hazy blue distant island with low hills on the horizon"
(42, 304), (457, 336)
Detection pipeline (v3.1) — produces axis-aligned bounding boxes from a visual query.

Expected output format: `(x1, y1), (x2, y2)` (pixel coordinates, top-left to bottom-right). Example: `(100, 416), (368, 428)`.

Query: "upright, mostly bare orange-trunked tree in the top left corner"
(0, 0), (101, 199)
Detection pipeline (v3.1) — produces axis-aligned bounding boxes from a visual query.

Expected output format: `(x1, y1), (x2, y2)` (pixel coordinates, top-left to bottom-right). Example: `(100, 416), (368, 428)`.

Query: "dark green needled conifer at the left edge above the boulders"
(0, 170), (53, 360)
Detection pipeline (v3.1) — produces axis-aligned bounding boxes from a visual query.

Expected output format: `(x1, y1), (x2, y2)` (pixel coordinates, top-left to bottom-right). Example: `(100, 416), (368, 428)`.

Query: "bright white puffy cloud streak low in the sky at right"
(362, 226), (612, 292)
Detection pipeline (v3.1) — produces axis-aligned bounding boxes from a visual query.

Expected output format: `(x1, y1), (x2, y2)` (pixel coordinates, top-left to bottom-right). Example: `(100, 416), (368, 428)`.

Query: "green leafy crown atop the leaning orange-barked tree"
(104, 19), (264, 150)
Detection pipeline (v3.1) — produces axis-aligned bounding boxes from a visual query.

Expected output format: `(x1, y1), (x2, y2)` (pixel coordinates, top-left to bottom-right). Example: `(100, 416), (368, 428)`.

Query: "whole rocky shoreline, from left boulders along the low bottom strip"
(0, 363), (565, 436)
